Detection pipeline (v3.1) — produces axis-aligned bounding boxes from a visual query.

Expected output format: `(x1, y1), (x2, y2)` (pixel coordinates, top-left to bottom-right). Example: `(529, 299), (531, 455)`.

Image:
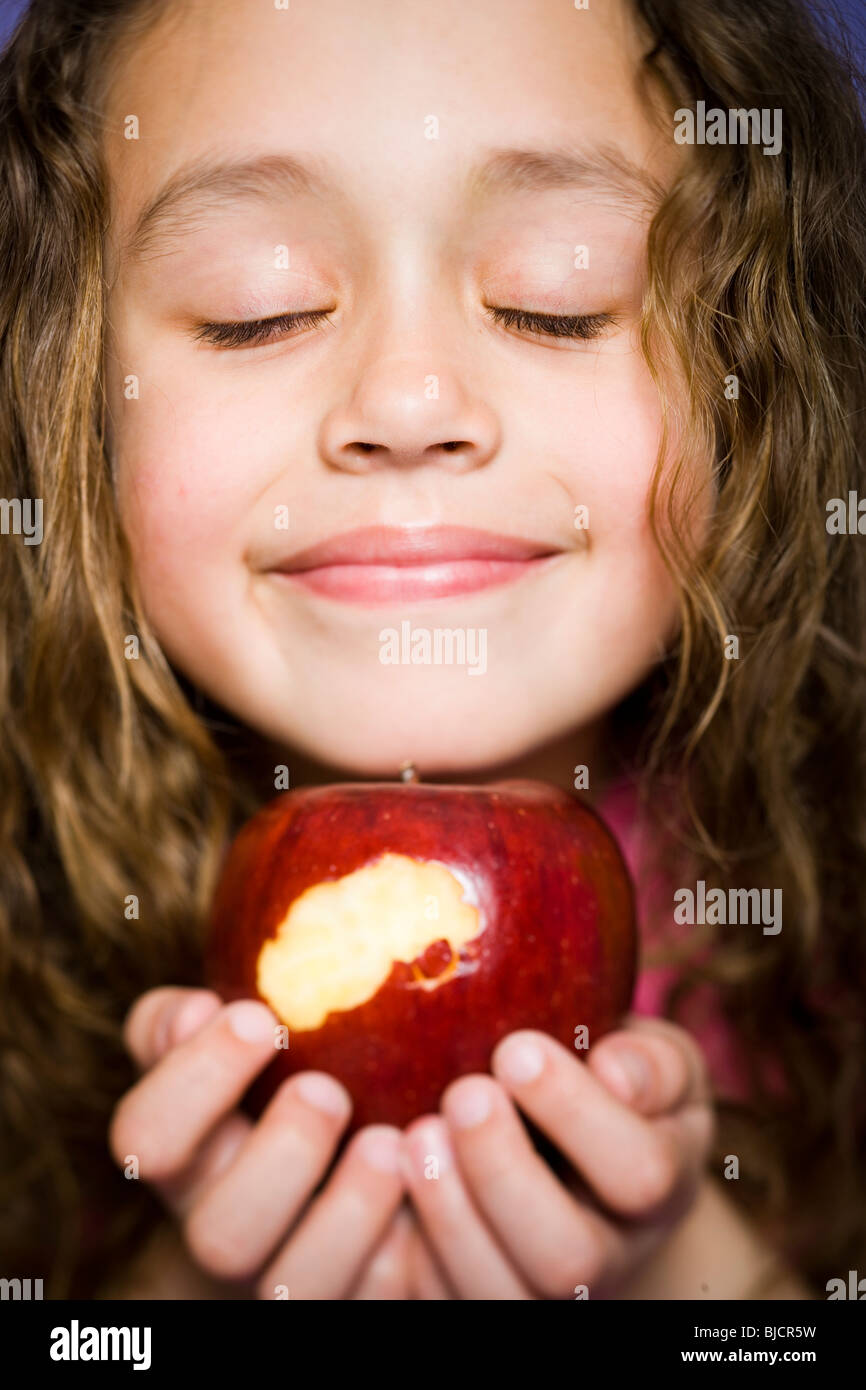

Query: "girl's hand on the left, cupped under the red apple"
(110, 987), (406, 1300)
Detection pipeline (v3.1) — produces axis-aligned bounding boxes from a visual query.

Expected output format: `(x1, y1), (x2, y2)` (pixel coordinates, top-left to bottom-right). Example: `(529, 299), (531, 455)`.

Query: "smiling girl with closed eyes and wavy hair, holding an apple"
(0, 0), (866, 1298)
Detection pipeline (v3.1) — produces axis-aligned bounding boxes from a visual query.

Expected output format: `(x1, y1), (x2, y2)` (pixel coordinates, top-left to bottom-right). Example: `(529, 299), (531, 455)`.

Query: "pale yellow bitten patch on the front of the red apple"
(257, 852), (482, 1031)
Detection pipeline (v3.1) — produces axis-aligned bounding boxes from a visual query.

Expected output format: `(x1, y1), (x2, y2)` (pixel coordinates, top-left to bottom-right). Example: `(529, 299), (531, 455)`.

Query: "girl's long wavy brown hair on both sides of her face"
(0, 0), (866, 1298)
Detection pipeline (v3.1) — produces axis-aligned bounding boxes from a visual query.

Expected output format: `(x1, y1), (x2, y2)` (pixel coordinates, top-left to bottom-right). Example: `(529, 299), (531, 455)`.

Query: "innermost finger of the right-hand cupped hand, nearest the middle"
(406, 1115), (531, 1300)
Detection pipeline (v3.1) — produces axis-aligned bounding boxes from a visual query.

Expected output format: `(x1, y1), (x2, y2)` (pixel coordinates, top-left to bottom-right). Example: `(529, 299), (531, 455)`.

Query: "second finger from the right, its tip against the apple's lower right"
(491, 1030), (709, 1218)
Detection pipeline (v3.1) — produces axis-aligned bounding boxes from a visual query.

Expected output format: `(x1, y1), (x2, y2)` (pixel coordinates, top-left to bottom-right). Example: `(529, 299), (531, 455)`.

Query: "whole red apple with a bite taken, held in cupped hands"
(206, 781), (637, 1129)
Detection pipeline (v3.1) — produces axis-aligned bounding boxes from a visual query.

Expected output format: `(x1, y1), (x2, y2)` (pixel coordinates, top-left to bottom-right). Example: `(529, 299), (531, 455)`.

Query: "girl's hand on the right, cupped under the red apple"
(406, 1015), (714, 1300)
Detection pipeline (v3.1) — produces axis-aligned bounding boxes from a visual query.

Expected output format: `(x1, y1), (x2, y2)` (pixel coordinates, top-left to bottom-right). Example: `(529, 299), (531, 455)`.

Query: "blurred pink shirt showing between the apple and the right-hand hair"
(598, 780), (748, 1099)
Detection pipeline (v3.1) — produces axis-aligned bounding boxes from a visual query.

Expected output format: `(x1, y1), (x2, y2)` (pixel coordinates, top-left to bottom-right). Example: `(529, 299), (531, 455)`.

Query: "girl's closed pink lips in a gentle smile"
(272, 525), (562, 603)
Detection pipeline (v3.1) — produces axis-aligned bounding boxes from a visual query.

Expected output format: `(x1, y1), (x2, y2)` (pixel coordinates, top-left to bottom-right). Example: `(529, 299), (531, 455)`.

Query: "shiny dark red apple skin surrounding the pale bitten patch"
(206, 781), (637, 1133)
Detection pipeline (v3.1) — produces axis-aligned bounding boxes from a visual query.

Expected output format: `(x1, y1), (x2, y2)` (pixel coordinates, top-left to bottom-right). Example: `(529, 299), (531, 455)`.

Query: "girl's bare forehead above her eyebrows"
(106, 0), (676, 261)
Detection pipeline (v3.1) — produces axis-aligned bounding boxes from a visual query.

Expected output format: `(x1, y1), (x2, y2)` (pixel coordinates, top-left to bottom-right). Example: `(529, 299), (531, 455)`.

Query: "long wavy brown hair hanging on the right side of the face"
(627, 0), (866, 1293)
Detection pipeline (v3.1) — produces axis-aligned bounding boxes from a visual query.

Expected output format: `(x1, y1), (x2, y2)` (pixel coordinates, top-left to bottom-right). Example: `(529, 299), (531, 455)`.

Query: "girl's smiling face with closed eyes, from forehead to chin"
(106, 0), (692, 776)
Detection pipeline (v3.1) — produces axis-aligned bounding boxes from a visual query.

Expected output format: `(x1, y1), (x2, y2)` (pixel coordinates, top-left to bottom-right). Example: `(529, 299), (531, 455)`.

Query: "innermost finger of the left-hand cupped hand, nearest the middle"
(257, 1125), (405, 1298)
